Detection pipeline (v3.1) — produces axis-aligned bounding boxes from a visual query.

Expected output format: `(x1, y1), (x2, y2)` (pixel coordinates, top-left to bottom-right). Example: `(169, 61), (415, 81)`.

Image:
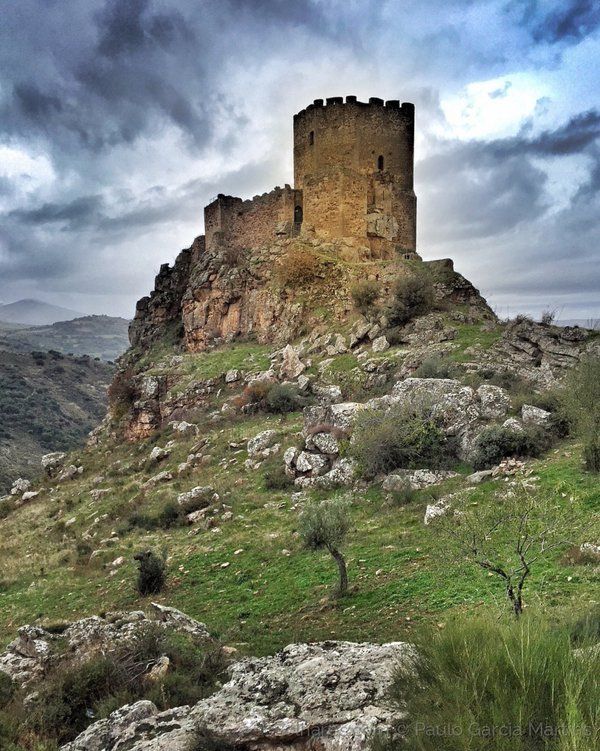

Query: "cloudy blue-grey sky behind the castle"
(0, 0), (600, 318)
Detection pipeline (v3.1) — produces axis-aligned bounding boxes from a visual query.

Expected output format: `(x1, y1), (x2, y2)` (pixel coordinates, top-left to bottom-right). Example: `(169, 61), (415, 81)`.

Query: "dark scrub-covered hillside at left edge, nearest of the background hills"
(0, 352), (113, 495)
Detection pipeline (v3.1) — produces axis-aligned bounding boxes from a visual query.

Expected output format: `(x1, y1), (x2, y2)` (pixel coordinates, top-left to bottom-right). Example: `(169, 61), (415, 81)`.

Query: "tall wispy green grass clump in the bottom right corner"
(377, 617), (600, 751)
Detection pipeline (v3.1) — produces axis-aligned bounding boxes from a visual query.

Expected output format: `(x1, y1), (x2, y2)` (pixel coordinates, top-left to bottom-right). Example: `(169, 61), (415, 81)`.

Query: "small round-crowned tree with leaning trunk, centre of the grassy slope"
(298, 498), (350, 596)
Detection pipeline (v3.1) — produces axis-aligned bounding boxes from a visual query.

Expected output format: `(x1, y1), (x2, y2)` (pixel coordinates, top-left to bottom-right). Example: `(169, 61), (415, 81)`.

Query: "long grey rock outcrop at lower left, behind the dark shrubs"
(0, 603), (210, 687)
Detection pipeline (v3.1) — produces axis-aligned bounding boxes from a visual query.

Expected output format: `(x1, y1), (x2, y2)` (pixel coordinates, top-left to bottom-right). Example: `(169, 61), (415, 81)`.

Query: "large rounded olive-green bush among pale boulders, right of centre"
(349, 406), (450, 478)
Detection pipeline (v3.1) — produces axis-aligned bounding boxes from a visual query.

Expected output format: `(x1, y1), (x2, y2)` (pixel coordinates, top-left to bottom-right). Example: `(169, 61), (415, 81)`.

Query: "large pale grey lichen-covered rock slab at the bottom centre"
(61, 641), (414, 751)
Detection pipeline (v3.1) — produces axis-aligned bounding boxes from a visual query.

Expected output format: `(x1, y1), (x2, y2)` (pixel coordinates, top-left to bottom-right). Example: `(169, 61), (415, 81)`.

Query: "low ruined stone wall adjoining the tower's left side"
(204, 185), (302, 250)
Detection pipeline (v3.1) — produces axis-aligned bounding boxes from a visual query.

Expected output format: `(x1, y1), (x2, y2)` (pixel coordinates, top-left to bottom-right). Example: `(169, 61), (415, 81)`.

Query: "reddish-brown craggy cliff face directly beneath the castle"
(130, 232), (494, 352)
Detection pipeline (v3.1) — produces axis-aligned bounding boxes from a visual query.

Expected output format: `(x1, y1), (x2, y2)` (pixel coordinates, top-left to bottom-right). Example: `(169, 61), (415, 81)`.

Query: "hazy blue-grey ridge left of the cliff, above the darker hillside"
(0, 308), (129, 360)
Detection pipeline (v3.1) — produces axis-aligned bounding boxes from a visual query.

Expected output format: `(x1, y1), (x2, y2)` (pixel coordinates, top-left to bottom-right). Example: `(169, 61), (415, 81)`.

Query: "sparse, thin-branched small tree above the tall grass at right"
(435, 480), (574, 618)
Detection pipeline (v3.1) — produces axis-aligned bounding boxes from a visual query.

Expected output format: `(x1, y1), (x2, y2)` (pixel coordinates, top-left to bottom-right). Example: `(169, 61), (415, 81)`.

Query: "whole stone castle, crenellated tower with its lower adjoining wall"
(204, 96), (416, 259)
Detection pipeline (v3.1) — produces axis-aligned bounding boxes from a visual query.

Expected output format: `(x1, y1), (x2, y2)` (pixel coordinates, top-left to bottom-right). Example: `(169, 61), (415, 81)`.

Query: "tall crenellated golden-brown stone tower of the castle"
(294, 96), (417, 258)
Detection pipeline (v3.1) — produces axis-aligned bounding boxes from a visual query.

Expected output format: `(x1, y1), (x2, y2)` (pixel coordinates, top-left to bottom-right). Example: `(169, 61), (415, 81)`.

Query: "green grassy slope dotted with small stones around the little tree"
(0, 331), (600, 653)
